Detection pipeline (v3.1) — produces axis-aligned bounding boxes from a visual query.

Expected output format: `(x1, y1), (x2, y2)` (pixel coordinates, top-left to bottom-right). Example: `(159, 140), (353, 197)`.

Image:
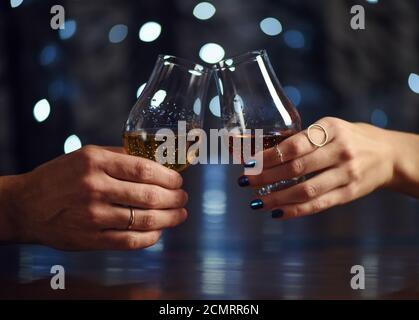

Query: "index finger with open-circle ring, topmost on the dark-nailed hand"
(263, 119), (335, 169)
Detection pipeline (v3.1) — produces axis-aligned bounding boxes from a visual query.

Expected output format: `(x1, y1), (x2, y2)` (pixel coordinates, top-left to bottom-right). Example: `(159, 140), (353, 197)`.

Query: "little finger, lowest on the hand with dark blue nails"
(272, 185), (354, 219)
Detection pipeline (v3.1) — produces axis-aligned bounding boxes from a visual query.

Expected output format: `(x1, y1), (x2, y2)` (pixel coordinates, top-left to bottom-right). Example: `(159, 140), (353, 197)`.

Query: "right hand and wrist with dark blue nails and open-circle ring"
(244, 117), (419, 219)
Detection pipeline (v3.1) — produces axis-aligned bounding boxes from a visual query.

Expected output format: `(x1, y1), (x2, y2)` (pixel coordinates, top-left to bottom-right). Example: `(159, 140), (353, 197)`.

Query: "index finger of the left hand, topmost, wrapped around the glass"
(103, 150), (183, 189)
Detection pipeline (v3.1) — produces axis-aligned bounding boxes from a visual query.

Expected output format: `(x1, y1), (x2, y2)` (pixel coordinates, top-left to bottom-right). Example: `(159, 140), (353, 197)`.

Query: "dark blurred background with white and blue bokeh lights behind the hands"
(0, 0), (419, 298)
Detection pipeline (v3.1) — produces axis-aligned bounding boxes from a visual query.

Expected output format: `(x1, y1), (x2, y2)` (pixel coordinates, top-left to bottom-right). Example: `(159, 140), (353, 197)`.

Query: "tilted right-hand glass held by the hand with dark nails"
(216, 50), (301, 195)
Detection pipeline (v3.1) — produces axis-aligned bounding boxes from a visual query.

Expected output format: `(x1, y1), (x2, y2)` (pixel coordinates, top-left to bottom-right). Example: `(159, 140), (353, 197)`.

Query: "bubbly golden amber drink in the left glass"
(122, 132), (194, 172)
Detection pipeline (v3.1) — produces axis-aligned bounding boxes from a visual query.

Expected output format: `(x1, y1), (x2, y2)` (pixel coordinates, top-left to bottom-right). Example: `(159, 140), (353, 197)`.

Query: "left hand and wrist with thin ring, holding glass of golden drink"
(0, 146), (188, 250)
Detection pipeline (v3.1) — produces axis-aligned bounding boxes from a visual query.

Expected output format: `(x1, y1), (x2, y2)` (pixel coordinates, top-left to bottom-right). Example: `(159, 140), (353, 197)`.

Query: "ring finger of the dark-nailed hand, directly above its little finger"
(261, 168), (350, 210)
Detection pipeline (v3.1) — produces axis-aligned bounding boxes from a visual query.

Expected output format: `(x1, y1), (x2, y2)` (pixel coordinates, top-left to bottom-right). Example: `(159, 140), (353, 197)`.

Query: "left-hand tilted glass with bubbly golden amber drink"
(123, 55), (211, 171)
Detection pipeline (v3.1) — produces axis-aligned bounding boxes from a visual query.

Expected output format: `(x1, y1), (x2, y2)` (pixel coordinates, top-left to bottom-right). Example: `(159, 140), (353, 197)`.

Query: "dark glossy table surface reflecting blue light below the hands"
(0, 165), (419, 299)
